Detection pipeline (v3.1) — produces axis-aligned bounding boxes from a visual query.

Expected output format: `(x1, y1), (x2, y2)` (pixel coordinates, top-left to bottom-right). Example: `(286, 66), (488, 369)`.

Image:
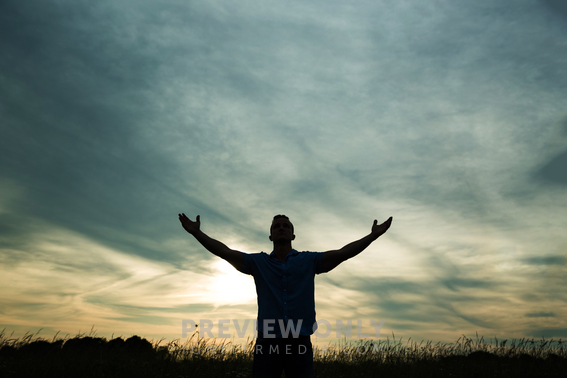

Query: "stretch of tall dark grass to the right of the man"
(315, 335), (567, 377)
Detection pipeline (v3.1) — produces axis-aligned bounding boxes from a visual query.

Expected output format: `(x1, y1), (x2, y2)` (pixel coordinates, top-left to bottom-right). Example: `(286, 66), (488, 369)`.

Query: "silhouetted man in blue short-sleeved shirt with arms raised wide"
(179, 213), (392, 377)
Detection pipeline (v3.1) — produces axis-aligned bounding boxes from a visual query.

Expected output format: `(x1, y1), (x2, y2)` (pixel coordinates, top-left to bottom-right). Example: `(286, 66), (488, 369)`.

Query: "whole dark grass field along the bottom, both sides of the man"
(0, 332), (567, 378)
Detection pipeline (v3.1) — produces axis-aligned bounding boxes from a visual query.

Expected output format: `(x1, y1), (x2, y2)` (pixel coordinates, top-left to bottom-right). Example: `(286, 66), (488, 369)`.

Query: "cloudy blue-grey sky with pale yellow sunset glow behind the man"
(0, 0), (567, 342)
